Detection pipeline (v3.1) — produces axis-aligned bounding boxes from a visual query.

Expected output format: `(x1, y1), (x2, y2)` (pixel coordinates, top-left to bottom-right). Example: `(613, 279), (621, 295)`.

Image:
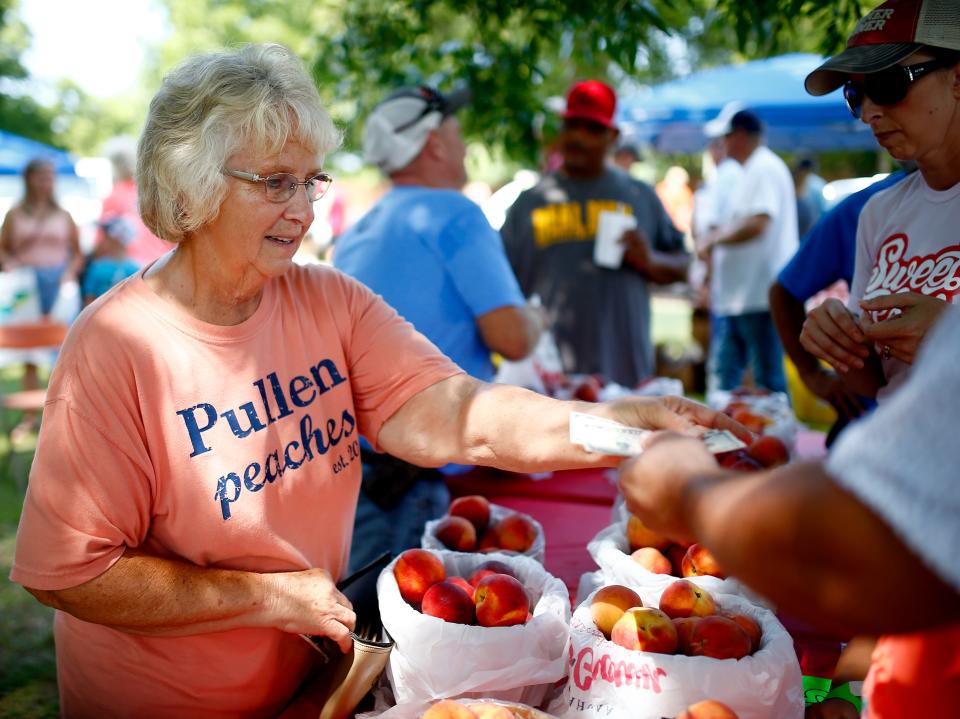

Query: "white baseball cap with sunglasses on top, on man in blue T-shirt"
(363, 86), (470, 173)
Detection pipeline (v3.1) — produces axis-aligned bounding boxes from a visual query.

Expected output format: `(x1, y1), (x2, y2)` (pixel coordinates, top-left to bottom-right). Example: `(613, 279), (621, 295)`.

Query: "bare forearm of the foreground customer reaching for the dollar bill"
(685, 464), (960, 635)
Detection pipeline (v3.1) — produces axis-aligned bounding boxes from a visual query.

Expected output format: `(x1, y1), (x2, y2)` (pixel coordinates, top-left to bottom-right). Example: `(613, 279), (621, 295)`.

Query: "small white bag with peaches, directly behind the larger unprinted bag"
(420, 494), (547, 564)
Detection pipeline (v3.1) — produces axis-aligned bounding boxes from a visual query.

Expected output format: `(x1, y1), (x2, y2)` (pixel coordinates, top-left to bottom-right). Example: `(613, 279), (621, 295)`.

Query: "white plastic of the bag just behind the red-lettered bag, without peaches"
(587, 519), (769, 606)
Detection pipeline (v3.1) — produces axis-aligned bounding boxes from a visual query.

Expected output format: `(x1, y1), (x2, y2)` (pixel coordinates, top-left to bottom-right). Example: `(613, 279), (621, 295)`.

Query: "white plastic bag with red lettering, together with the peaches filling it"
(547, 580), (804, 719)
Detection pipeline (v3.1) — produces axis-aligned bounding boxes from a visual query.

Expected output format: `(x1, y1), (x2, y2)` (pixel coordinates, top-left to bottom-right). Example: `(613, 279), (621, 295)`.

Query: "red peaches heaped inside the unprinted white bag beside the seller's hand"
(393, 549), (531, 627)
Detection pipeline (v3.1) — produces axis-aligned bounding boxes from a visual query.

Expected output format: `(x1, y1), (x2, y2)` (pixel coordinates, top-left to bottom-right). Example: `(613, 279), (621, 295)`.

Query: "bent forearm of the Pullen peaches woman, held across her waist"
(30, 550), (267, 636)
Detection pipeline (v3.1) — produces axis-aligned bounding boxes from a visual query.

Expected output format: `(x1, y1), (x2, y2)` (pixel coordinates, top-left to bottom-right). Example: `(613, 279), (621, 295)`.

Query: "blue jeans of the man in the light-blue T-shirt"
(348, 465), (450, 574)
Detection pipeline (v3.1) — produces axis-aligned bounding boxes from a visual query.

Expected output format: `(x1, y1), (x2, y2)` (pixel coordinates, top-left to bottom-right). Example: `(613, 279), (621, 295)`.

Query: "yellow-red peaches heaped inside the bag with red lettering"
(590, 579), (763, 659)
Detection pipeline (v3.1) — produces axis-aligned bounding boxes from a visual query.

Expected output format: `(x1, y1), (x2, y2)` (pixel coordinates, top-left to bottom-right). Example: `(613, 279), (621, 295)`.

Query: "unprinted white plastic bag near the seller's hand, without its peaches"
(377, 551), (570, 706)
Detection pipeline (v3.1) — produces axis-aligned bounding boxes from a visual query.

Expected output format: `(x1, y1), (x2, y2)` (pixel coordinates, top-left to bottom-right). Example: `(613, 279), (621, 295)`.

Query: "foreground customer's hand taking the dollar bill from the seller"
(620, 432), (719, 541)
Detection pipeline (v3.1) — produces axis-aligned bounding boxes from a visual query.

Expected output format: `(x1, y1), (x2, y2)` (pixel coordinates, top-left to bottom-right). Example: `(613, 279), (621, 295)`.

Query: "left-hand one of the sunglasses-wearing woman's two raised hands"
(800, 297), (870, 372)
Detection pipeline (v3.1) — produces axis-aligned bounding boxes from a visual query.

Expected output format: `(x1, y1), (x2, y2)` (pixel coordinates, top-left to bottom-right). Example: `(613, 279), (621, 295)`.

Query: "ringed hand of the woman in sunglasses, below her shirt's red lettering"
(860, 292), (947, 364)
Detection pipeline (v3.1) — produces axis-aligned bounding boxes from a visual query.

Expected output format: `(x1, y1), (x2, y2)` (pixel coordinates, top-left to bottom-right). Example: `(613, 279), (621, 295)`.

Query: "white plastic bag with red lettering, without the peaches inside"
(548, 593), (804, 719)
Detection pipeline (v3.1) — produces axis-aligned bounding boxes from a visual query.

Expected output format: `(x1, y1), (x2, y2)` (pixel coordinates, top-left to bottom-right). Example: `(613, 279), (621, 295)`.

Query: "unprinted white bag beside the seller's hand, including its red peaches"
(377, 549), (570, 706)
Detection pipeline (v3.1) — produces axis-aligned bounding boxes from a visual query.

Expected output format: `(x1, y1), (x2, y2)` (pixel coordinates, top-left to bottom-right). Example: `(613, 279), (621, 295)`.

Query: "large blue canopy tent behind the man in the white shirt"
(617, 53), (878, 153)
